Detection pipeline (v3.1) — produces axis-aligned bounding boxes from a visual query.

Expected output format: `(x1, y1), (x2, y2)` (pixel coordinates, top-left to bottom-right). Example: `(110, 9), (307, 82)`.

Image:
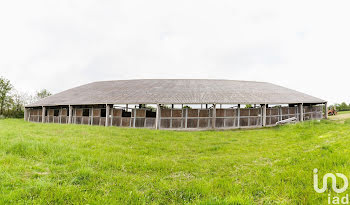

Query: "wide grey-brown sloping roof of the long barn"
(27, 79), (326, 107)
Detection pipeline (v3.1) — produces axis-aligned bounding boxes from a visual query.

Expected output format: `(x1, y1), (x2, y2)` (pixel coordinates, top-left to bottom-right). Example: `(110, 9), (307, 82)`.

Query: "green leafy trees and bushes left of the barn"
(0, 76), (51, 118)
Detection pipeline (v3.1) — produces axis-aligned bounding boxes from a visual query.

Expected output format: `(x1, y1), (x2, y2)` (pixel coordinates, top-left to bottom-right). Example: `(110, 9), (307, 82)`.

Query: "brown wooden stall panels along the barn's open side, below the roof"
(27, 105), (323, 129)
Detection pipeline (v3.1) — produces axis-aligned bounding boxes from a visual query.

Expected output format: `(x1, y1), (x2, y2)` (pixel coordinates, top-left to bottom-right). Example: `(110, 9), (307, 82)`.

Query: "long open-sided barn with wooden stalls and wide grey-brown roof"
(24, 79), (327, 129)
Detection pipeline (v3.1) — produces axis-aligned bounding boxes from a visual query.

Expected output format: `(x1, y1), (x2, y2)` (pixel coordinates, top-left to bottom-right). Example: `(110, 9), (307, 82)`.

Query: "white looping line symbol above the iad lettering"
(314, 169), (349, 193)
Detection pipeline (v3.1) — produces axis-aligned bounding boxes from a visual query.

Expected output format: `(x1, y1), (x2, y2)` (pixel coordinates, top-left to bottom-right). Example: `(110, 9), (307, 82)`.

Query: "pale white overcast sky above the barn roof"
(0, 0), (350, 103)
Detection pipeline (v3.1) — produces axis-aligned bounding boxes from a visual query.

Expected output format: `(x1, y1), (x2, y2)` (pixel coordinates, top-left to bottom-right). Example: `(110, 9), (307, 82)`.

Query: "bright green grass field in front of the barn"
(0, 119), (350, 204)
